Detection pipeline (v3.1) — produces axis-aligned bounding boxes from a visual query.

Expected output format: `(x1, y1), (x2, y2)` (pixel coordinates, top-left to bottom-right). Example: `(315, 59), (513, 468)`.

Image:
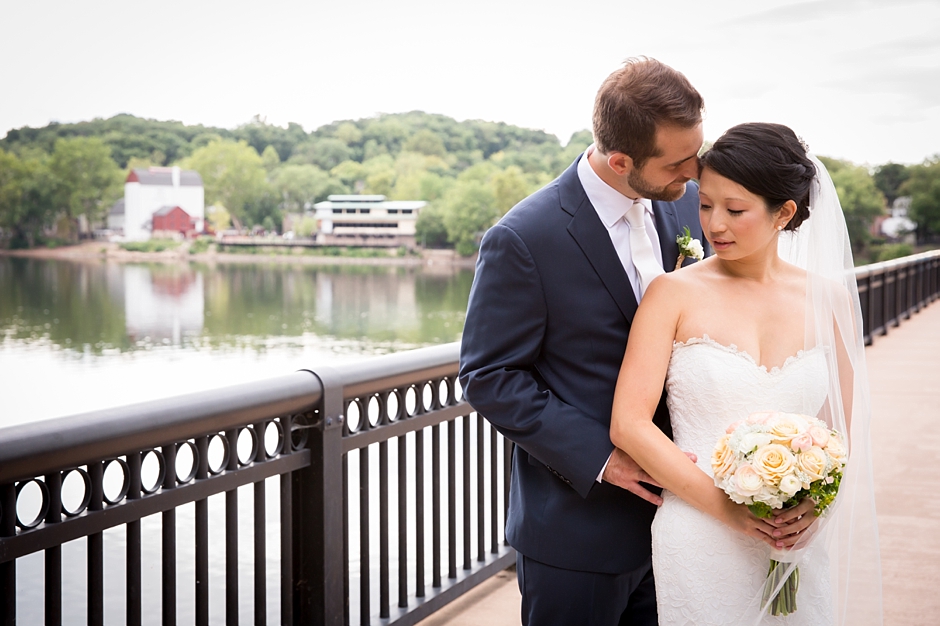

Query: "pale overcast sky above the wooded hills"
(0, 0), (940, 165)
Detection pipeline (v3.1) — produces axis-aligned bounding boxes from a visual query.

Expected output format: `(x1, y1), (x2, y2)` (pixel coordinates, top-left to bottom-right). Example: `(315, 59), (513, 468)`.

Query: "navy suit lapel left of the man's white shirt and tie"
(559, 161), (637, 322)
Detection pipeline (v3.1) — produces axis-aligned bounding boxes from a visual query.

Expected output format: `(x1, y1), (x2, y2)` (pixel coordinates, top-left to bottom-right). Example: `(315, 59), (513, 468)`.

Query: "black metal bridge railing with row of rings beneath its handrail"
(0, 252), (940, 625)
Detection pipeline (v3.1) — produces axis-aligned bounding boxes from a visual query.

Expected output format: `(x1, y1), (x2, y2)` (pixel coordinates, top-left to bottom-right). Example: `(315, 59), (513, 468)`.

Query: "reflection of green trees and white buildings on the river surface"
(0, 258), (473, 353)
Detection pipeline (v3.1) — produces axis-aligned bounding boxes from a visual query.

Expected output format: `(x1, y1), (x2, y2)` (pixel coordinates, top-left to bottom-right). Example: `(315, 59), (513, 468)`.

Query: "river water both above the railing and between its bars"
(0, 257), (484, 624)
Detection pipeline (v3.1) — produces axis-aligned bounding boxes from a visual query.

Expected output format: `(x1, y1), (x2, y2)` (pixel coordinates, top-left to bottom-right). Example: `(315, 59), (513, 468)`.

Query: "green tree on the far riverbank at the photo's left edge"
(0, 150), (52, 248)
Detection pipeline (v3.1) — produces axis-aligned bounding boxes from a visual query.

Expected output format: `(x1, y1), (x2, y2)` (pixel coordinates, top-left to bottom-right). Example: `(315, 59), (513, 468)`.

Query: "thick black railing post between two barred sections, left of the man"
(292, 367), (348, 626)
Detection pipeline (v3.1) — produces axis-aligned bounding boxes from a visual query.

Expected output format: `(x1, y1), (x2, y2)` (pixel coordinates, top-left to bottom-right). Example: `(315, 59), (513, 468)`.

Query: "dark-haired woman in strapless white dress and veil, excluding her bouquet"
(610, 124), (882, 626)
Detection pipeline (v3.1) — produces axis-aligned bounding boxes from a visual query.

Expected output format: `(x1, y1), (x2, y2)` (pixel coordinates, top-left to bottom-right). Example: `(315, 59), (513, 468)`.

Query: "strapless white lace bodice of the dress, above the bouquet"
(666, 335), (828, 476)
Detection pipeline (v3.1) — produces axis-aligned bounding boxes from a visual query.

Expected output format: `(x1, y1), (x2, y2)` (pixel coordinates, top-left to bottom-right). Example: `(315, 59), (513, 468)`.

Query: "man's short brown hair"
(594, 57), (705, 169)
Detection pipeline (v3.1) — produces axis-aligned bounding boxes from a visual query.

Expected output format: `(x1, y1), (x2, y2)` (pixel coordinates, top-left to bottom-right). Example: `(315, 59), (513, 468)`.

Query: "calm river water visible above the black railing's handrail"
(0, 257), (473, 427)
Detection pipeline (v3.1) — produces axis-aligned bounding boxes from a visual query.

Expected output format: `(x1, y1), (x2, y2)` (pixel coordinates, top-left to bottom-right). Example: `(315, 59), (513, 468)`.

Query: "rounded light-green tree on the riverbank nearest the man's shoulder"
(441, 179), (499, 256)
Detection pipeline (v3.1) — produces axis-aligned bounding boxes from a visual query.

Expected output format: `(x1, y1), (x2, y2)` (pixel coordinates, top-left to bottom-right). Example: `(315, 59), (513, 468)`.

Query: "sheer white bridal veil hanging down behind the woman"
(772, 156), (883, 626)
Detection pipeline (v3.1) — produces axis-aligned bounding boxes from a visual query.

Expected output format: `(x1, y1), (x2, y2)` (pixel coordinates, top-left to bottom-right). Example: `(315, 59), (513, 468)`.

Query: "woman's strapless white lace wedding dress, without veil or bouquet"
(652, 335), (834, 626)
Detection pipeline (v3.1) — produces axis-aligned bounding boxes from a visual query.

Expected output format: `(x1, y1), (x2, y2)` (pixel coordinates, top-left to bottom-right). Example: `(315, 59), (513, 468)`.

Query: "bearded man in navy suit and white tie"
(460, 59), (704, 626)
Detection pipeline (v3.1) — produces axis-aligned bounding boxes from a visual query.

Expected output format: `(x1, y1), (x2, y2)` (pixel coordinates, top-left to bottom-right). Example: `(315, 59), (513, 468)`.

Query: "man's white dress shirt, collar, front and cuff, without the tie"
(578, 144), (663, 482)
